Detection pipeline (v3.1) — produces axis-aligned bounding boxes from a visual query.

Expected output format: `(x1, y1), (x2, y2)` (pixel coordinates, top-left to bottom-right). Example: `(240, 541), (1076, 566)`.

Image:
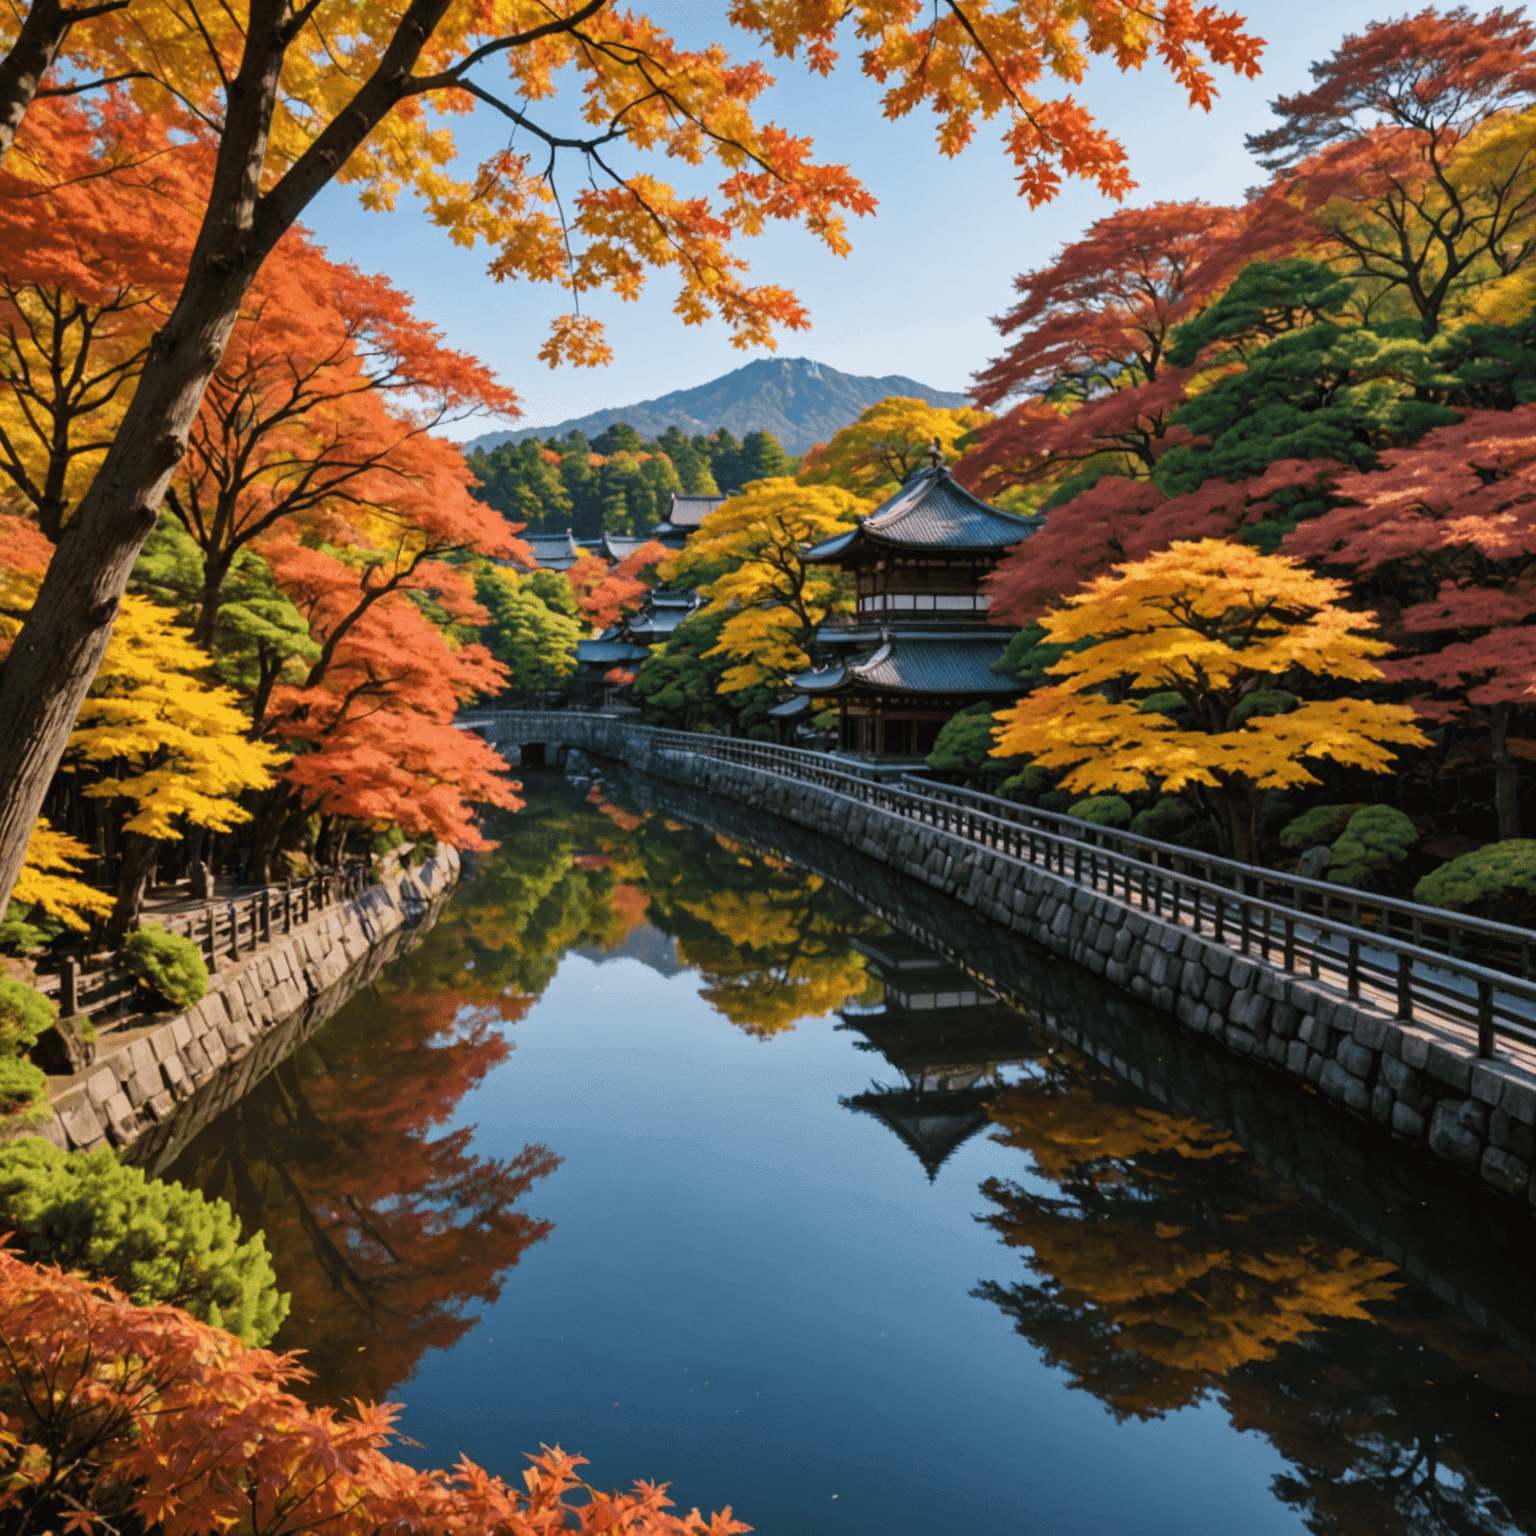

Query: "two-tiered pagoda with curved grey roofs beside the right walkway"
(793, 462), (1037, 760)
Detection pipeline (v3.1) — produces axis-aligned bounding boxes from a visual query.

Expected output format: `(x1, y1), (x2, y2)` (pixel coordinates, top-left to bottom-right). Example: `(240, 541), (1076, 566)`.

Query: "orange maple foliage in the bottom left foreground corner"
(0, 1250), (751, 1536)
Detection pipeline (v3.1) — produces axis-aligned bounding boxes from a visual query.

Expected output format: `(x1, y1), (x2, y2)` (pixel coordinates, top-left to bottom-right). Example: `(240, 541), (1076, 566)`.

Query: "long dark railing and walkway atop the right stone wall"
(485, 711), (1536, 1057)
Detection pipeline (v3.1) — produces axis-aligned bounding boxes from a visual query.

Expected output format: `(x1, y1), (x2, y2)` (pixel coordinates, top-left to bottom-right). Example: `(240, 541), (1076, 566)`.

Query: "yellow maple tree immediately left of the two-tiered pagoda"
(675, 476), (871, 693)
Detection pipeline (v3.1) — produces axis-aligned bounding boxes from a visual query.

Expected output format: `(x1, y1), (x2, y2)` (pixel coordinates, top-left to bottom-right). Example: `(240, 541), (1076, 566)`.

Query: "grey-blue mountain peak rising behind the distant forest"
(468, 358), (969, 455)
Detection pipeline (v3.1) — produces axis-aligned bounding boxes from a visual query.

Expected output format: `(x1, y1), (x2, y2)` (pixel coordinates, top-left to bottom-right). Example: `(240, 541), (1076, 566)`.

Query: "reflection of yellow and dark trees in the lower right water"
(975, 1049), (1536, 1536)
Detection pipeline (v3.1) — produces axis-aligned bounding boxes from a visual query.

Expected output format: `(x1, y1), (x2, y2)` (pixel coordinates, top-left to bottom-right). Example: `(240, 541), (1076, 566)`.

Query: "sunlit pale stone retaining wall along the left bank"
(37, 848), (459, 1166)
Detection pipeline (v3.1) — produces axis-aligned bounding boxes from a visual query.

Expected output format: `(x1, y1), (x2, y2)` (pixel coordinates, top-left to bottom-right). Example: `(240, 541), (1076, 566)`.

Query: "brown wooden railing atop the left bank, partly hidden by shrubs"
(38, 862), (369, 1032)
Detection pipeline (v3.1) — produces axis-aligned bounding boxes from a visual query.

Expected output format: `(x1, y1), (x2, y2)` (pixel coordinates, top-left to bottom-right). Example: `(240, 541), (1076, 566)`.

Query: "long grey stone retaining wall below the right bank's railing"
(481, 713), (1536, 1204)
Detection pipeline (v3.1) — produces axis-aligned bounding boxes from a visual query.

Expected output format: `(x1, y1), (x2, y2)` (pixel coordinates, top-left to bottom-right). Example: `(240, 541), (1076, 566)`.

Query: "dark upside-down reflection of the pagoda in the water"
(837, 932), (1038, 1183)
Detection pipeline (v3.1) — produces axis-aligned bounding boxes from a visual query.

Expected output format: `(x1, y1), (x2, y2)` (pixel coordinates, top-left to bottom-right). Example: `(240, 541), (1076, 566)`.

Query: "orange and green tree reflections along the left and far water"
(164, 783), (883, 1404)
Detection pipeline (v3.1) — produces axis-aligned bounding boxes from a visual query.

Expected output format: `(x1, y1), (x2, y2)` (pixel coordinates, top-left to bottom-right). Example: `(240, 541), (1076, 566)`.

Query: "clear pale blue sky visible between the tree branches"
(309, 0), (1437, 425)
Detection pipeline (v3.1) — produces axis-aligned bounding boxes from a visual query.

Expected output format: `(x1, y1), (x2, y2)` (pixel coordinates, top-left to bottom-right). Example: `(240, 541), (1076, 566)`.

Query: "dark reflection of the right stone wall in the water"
(624, 774), (1536, 1361)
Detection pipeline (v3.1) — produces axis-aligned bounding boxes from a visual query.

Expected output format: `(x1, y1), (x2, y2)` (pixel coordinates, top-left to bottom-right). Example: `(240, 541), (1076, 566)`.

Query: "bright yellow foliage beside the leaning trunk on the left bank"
(65, 596), (280, 837)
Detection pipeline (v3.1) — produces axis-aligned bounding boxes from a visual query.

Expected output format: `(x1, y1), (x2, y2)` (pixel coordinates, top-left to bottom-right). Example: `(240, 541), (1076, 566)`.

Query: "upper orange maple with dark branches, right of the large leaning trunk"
(169, 229), (531, 644)
